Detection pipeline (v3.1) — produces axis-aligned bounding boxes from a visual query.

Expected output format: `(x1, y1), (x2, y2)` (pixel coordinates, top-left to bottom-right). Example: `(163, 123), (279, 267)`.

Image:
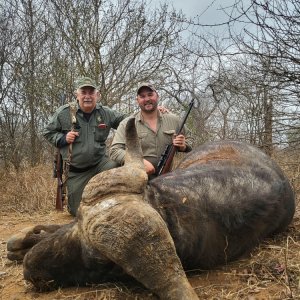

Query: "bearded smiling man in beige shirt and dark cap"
(110, 83), (192, 179)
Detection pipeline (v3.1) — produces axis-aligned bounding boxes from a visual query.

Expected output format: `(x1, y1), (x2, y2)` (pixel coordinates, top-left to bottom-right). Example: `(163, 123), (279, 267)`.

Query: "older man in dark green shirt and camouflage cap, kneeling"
(43, 77), (127, 216)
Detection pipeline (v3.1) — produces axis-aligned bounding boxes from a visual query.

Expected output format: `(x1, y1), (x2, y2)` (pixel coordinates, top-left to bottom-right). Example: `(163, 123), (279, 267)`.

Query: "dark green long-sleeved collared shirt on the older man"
(43, 103), (127, 169)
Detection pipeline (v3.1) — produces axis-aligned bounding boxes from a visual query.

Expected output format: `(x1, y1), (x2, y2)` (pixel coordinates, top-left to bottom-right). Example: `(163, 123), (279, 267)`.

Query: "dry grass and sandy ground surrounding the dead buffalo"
(0, 152), (300, 300)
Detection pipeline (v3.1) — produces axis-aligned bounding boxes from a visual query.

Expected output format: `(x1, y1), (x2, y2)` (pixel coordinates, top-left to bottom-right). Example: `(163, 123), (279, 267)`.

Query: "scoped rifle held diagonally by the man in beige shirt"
(156, 99), (194, 176)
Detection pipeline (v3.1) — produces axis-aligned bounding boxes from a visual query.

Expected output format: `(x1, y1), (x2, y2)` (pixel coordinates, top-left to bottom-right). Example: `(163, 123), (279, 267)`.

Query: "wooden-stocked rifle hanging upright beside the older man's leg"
(53, 148), (66, 210)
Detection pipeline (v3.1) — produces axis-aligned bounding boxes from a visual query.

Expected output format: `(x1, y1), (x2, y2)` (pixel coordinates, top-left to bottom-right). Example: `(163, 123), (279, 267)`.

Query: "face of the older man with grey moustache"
(76, 86), (99, 113)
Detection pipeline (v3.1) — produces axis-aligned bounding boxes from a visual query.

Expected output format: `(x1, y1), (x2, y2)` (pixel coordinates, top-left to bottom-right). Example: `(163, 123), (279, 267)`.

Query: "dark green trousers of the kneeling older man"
(66, 156), (119, 216)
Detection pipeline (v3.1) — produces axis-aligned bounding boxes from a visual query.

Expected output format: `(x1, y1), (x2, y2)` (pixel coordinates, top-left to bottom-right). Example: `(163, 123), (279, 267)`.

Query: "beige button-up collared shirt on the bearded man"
(110, 112), (192, 171)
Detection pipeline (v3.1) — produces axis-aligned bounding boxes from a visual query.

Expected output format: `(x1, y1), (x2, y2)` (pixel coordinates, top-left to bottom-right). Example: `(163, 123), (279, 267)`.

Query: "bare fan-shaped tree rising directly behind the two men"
(47, 0), (182, 109)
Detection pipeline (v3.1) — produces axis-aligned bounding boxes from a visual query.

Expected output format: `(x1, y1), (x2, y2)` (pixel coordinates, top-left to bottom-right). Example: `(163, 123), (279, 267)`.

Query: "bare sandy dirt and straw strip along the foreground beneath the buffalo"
(0, 209), (300, 300)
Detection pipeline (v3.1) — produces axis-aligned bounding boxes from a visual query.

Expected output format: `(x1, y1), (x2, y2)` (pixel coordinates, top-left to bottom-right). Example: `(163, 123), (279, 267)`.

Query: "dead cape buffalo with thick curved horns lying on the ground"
(7, 121), (295, 300)
